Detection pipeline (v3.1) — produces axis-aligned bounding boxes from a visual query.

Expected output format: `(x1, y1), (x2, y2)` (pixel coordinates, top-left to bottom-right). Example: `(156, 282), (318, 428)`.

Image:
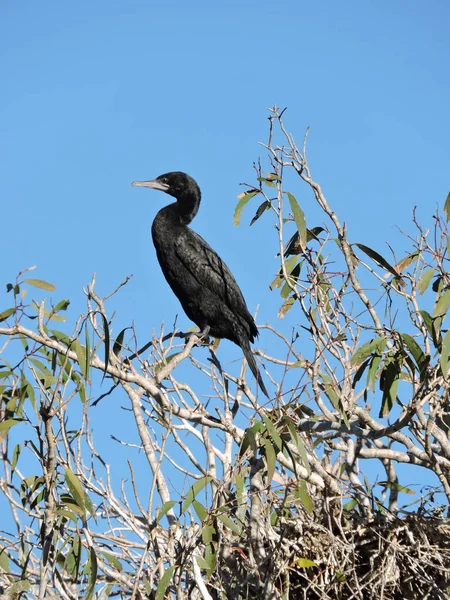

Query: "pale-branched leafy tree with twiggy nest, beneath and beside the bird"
(0, 107), (450, 600)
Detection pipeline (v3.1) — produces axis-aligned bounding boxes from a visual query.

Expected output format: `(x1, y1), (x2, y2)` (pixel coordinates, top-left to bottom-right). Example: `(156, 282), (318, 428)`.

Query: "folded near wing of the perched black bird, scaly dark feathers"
(175, 229), (253, 322)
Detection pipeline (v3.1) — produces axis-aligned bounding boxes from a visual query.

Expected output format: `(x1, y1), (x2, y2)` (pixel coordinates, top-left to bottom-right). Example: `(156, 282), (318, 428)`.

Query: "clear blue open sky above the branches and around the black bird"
(0, 0), (450, 506)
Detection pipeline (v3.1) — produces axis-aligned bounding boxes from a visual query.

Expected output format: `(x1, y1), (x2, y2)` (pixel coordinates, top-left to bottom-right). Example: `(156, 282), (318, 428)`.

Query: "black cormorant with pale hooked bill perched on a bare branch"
(131, 171), (269, 398)
